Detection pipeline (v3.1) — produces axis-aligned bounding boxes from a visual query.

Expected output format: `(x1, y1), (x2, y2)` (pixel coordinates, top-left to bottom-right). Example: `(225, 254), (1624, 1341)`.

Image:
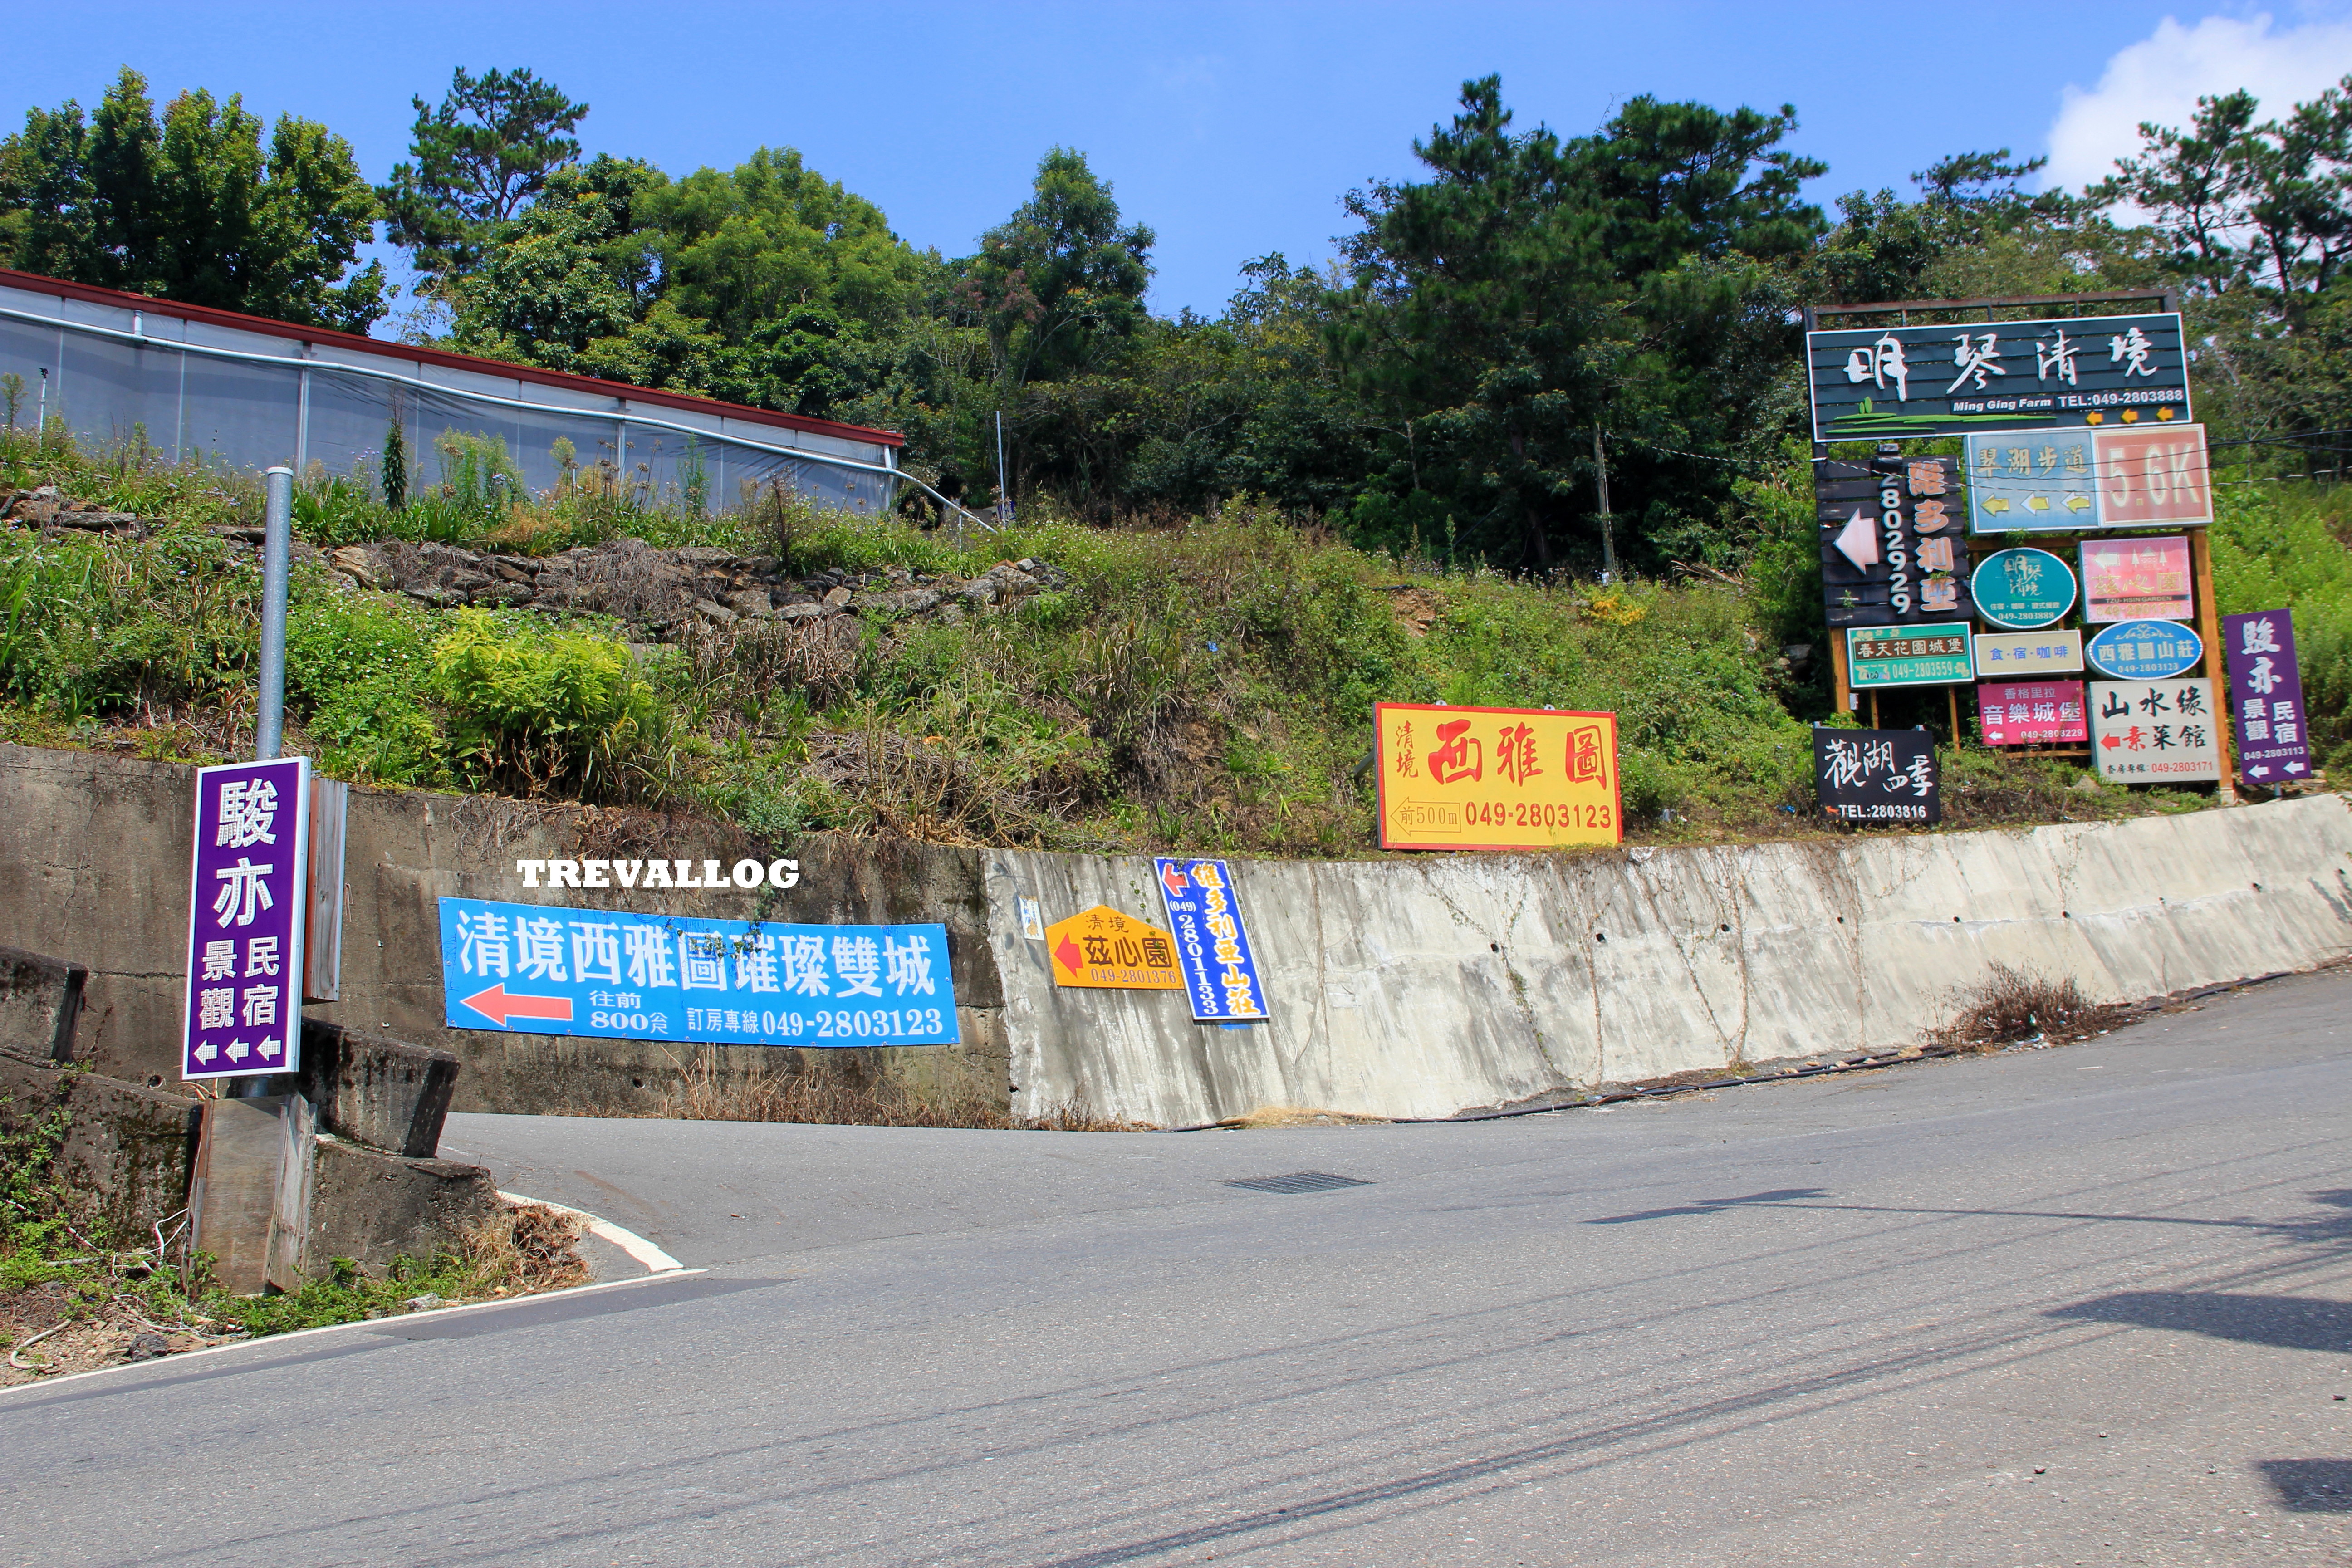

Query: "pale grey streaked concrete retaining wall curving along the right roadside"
(988, 794), (2352, 1126)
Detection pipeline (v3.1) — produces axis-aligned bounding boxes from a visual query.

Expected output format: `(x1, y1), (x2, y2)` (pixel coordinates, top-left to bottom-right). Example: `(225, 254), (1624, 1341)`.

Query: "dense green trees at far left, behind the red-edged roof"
(0, 66), (386, 332)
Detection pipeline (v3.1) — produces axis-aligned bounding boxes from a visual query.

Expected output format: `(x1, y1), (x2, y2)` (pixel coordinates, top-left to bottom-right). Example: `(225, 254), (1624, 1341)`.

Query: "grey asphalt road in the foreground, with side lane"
(0, 973), (2352, 1568)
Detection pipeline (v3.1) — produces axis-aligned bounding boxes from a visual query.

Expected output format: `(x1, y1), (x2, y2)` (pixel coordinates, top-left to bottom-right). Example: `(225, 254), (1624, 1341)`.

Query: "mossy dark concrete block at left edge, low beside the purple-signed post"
(0, 1051), (197, 1239)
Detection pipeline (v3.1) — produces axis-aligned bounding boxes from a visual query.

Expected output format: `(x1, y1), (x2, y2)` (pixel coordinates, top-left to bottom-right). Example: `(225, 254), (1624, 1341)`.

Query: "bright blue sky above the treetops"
(14, 0), (2352, 313)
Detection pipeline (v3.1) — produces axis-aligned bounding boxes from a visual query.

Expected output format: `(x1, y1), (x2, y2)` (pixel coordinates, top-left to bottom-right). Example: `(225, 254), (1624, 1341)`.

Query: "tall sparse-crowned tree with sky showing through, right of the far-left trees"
(376, 66), (588, 280)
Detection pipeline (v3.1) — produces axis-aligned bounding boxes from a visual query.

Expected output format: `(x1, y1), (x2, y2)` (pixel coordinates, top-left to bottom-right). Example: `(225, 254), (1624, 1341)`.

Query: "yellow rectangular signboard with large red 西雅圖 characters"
(1373, 703), (1625, 848)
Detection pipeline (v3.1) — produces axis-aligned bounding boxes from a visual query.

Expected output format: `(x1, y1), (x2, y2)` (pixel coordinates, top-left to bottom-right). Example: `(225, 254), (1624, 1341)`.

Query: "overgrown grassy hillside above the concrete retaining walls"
(0, 432), (2352, 856)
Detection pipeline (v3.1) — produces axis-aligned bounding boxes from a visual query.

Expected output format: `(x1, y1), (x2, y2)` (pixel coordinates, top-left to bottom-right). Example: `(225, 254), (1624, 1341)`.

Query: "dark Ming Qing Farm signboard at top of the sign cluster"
(1804, 313), (2190, 442)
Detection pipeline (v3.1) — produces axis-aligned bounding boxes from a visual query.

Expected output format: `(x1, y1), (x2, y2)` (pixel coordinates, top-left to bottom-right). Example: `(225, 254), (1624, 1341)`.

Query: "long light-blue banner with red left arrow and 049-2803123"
(440, 898), (960, 1046)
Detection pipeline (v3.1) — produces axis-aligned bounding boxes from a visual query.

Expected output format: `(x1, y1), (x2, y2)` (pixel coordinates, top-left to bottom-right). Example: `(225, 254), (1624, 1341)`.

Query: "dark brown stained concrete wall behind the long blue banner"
(0, 745), (1011, 1112)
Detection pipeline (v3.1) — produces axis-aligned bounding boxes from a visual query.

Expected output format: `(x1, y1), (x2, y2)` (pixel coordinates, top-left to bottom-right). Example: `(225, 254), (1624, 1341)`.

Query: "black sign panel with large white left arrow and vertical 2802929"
(1813, 458), (1976, 627)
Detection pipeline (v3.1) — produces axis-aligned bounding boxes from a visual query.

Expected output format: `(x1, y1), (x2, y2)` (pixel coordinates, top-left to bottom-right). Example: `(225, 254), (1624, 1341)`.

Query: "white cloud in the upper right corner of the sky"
(2044, 14), (2352, 191)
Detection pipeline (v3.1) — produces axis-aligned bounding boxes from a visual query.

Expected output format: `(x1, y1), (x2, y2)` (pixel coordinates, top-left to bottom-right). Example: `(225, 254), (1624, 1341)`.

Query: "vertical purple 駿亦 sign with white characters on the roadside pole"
(181, 757), (310, 1079)
